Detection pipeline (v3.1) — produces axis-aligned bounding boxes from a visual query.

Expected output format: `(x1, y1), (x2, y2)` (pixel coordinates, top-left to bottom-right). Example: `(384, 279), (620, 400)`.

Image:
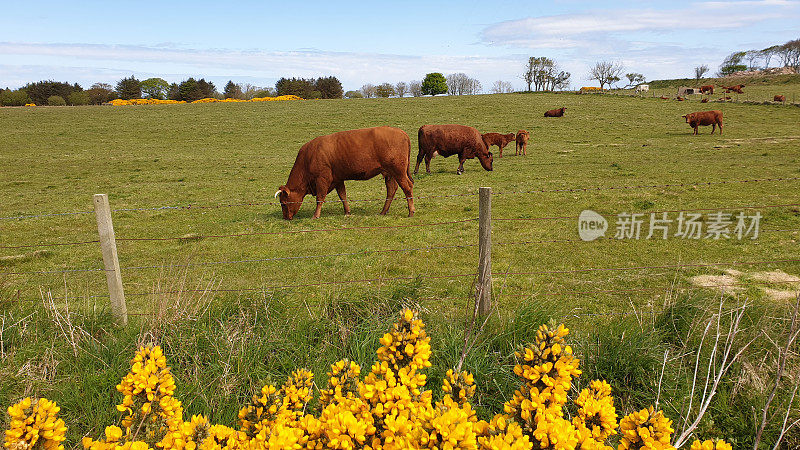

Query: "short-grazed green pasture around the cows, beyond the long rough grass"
(0, 90), (800, 313)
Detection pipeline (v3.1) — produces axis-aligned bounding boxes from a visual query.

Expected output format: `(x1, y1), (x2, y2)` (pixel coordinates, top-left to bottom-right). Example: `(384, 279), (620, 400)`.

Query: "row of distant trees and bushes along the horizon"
(0, 39), (800, 106)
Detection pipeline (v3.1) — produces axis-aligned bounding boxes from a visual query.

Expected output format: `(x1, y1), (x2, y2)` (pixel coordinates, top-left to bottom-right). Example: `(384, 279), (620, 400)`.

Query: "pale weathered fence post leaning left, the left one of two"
(94, 194), (128, 325)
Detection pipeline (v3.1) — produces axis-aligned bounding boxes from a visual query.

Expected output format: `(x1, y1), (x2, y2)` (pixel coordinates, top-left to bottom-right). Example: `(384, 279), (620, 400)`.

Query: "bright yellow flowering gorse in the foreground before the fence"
(5, 309), (730, 450)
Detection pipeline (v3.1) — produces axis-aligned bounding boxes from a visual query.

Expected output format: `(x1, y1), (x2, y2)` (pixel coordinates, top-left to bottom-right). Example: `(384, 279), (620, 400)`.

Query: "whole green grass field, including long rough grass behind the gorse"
(0, 87), (800, 445)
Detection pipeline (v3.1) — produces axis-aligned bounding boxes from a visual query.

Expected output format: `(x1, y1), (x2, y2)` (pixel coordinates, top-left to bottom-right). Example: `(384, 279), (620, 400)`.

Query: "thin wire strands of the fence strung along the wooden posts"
(0, 177), (800, 322)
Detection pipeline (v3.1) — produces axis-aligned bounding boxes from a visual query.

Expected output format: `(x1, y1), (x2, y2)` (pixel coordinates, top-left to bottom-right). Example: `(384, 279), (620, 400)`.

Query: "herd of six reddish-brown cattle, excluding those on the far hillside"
(275, 103), (722, 220)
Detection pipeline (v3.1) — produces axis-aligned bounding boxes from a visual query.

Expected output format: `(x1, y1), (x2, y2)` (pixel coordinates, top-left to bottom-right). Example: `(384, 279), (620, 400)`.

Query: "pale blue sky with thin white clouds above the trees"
(0, 0), (800, 90)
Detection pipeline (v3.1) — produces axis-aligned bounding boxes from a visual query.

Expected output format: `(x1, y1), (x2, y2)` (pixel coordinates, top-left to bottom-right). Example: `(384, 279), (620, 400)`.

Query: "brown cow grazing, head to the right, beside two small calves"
(414, 125), (494, 175)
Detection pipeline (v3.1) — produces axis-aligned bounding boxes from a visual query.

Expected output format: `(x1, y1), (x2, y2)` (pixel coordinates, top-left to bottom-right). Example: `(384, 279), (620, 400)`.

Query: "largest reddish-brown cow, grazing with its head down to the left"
(275, 127), (414, 220)
